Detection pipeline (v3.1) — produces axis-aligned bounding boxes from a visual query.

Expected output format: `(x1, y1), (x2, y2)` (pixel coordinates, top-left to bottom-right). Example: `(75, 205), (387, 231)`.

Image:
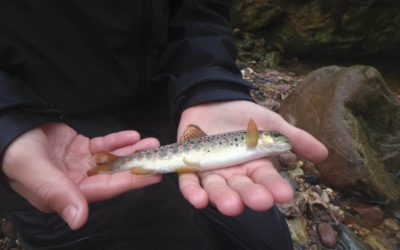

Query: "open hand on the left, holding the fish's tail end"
(2, 123), (161, 229)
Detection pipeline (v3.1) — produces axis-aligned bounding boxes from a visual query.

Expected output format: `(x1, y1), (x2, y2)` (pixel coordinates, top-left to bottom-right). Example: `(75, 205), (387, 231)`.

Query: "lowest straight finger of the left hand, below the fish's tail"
(79, 172), (161, 202)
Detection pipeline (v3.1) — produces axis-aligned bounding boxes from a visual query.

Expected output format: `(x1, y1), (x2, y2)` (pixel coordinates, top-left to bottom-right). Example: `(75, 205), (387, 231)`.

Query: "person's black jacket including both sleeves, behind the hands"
(0, 0), (250, 247)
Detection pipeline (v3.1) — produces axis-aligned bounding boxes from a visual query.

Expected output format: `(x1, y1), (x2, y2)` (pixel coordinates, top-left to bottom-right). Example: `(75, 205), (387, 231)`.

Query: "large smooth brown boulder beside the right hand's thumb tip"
(280, 66), (400, 204)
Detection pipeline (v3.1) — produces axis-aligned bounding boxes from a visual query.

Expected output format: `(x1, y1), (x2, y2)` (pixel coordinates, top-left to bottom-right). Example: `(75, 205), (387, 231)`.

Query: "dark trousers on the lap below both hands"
(19, 176), (293, 250)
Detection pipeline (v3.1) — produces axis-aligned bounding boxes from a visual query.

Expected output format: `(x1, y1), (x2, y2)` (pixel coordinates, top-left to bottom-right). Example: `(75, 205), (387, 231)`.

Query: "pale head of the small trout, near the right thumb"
(258, 131), (292, 153)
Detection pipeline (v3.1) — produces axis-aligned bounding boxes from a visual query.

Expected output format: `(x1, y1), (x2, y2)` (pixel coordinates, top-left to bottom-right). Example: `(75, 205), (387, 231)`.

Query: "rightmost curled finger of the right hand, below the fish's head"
(250, 162), (293, 203)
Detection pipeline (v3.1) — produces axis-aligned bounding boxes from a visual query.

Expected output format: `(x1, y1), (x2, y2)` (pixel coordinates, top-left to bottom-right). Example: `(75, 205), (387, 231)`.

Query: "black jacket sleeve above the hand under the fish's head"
(156, 0), (252, 119)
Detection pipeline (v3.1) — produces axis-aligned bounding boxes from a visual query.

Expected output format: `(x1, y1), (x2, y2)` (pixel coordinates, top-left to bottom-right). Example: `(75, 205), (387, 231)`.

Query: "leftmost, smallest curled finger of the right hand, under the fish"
(179, 173), (208, 209)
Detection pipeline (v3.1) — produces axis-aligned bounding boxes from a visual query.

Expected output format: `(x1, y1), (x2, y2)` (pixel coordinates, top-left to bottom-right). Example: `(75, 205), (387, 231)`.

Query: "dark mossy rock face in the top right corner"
(231, 0), (400, 57)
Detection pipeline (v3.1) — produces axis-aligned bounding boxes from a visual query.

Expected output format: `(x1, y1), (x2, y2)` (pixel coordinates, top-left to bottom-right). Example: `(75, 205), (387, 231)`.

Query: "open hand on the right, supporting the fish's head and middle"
(178, 101), (328, 216)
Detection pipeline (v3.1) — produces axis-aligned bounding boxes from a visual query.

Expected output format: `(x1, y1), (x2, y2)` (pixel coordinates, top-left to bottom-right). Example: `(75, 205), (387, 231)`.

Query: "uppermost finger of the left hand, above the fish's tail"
(89, 130), (140, 154)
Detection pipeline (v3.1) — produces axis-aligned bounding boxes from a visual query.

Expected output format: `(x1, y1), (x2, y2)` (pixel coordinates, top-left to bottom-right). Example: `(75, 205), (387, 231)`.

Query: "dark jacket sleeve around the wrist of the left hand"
(0, 43), (59, 211)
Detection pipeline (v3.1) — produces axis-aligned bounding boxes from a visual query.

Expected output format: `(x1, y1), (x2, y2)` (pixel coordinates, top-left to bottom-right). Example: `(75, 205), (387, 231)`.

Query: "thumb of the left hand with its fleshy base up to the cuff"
(2, 129), (88, 229)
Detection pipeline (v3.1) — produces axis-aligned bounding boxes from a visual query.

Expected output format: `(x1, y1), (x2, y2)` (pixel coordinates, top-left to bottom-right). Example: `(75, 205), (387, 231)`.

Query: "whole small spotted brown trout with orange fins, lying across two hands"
(87, 119), (292, 176)
